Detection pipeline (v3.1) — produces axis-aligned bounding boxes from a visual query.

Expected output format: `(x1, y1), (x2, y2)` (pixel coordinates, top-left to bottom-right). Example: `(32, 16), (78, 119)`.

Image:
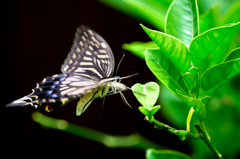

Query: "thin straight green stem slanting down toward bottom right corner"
(194, 123), (222, 159)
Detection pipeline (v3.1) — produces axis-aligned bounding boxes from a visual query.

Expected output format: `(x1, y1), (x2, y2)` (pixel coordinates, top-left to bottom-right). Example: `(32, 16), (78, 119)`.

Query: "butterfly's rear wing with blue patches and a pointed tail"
(7, 74), (98, 108)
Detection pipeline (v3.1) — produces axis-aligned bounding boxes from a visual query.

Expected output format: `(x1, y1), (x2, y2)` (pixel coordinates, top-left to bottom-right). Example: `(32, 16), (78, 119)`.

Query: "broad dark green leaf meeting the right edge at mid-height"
(201, 59), (240, 95)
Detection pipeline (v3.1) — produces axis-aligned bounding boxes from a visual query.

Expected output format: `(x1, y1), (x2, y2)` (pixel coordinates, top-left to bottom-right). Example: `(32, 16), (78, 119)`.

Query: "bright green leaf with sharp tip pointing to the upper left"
(140, 24), (190, 74)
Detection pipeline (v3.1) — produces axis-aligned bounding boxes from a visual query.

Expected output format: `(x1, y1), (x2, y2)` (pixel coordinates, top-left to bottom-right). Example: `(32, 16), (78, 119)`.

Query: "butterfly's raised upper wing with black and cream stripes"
(61, 25), (114, 80)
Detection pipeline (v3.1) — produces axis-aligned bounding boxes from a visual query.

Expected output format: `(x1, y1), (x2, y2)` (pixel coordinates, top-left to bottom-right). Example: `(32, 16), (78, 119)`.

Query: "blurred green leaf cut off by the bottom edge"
(146, 148), (191, 159)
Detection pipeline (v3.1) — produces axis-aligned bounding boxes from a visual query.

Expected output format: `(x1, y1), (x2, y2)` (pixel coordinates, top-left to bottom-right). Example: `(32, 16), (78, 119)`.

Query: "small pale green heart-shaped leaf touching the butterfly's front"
(132, 82), (160, 109)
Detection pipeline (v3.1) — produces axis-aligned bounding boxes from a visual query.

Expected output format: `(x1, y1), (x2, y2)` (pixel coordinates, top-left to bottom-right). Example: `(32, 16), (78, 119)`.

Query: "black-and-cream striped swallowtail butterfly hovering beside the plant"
(7, 25), (131, 115)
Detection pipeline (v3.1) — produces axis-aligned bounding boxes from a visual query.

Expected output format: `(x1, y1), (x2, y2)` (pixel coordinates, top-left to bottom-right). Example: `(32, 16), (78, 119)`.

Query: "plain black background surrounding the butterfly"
(0, 0), (190, 158)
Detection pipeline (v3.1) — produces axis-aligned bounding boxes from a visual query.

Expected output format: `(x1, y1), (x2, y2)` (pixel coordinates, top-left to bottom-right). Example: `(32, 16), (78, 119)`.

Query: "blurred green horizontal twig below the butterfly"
(32, 112), (164, 150)
